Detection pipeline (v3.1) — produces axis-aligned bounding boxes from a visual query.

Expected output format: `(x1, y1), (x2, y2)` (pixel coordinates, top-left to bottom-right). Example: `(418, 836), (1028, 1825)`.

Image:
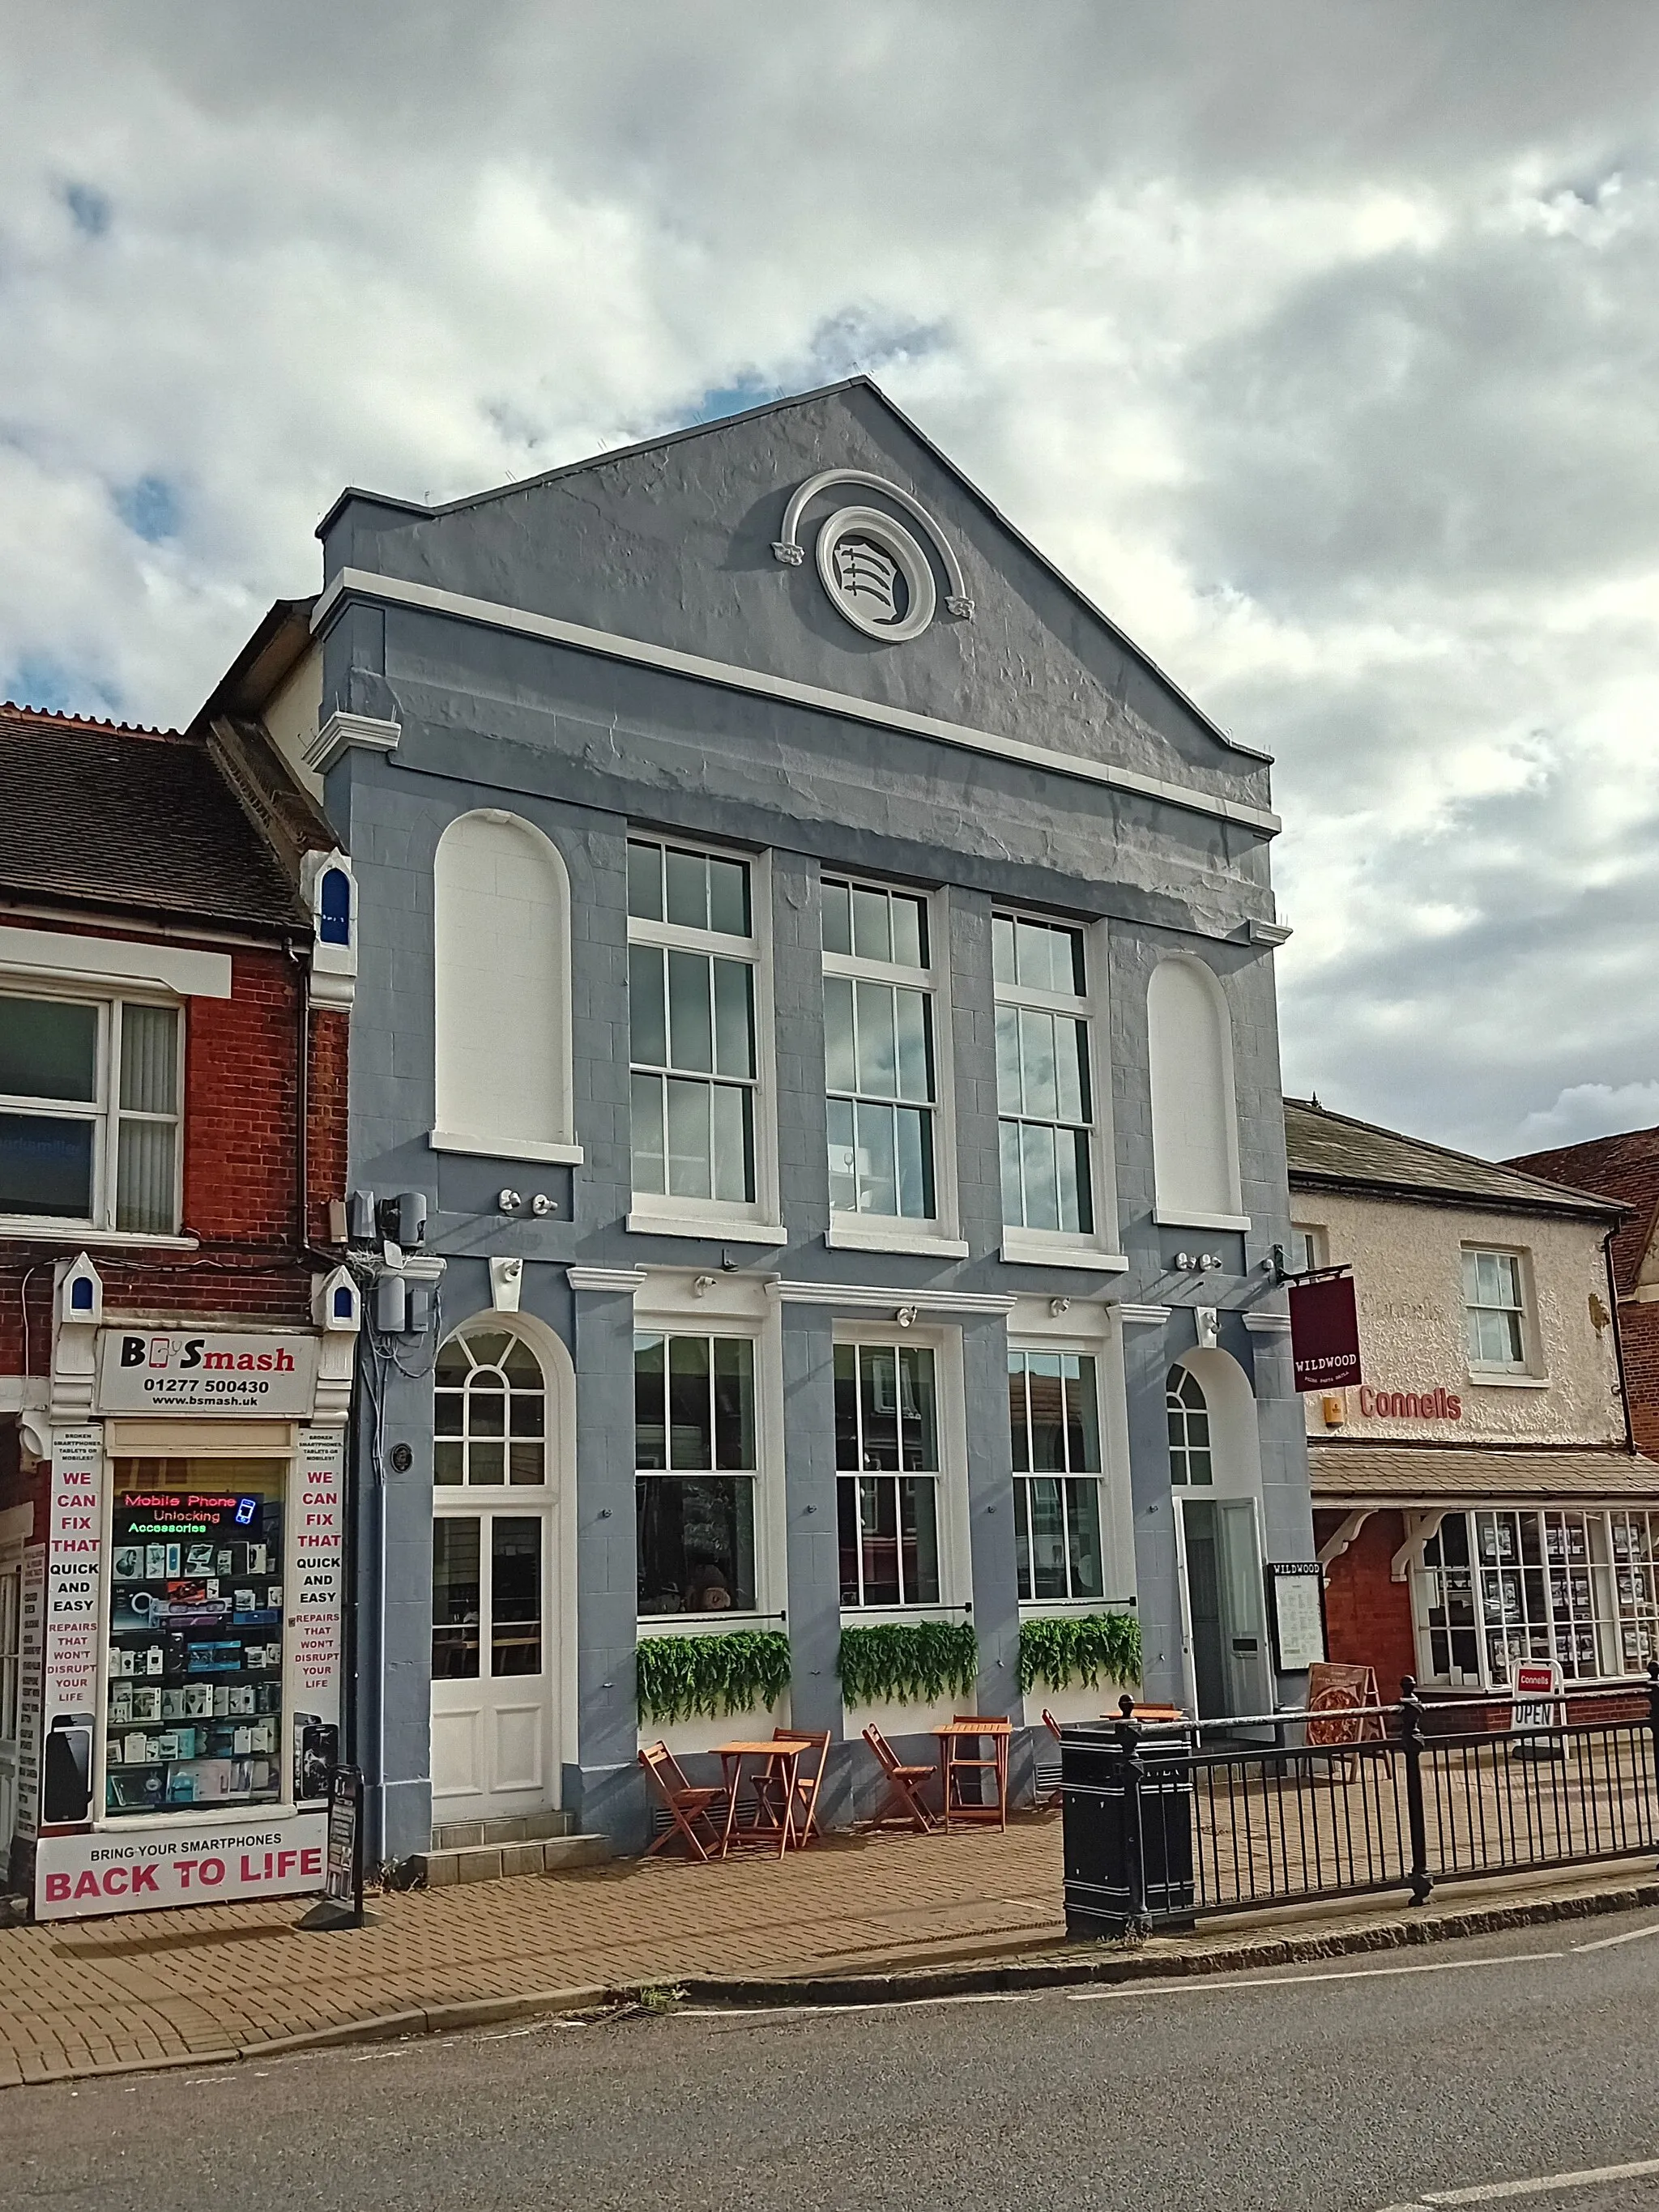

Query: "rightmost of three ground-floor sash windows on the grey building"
(1009, 1352), (1106, 1601)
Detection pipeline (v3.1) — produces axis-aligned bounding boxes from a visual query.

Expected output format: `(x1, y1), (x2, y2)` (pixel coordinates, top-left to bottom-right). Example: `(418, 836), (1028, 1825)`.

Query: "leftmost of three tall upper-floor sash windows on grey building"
(629, 838), (761, 1217)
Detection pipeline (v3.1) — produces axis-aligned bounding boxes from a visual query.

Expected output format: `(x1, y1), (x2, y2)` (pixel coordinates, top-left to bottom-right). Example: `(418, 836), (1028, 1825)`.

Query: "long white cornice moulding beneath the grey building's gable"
(308, 569), (1283, 836)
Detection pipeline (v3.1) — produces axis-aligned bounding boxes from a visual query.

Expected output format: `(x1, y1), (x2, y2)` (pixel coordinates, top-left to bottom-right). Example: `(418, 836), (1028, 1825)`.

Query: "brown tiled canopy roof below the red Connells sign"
(1307, 1443), (1659, 1507)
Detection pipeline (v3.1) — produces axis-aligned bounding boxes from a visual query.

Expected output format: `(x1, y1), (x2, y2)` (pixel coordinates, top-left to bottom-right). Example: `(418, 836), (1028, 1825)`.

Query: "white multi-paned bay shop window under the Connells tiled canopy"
(1414, 1509), (1659, 1690)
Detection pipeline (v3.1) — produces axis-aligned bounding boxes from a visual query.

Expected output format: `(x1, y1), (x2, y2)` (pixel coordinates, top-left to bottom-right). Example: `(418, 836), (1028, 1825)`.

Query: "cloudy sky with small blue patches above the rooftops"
(0, 0), (1659, 1153)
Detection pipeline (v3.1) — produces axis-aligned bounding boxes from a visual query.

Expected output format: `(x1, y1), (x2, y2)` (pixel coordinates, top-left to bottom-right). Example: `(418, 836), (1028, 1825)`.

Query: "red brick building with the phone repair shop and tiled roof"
(0, 705), (358, 1912)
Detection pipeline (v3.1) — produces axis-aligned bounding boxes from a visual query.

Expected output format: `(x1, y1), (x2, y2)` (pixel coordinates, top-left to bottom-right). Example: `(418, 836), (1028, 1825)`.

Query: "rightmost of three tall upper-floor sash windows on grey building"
(991, 911), (1126, 1270)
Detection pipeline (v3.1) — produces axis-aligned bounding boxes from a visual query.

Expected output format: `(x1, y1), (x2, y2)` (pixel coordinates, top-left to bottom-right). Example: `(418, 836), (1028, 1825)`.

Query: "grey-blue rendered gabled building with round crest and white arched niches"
(249, 378), (1311, 1858)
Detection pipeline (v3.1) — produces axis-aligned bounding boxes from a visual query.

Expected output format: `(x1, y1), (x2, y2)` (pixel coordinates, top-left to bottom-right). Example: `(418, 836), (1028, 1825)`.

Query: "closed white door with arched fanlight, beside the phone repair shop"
(431, 1325), (560, 1825)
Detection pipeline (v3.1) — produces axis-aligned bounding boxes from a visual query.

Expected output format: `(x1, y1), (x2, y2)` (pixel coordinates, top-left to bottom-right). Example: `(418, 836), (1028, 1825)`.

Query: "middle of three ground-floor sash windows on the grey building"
(834, 1325), (971, 1626)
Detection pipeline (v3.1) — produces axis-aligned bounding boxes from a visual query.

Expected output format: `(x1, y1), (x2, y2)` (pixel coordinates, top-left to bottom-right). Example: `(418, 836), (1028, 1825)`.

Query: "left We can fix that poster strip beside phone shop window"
(37, 1429), (104, 1834)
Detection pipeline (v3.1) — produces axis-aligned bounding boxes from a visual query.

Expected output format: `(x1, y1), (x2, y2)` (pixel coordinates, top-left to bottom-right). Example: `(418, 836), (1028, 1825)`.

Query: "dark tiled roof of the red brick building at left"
(0, 703), (308, 929)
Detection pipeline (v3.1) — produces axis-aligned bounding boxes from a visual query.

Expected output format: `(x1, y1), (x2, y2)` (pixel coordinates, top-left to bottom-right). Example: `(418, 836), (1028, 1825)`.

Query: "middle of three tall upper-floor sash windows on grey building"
(823, 874), (966, 1259)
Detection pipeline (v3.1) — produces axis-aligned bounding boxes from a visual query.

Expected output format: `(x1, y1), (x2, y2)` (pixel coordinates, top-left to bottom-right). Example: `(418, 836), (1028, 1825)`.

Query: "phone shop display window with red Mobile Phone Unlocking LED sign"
(107, 1460), (288, 1818)
